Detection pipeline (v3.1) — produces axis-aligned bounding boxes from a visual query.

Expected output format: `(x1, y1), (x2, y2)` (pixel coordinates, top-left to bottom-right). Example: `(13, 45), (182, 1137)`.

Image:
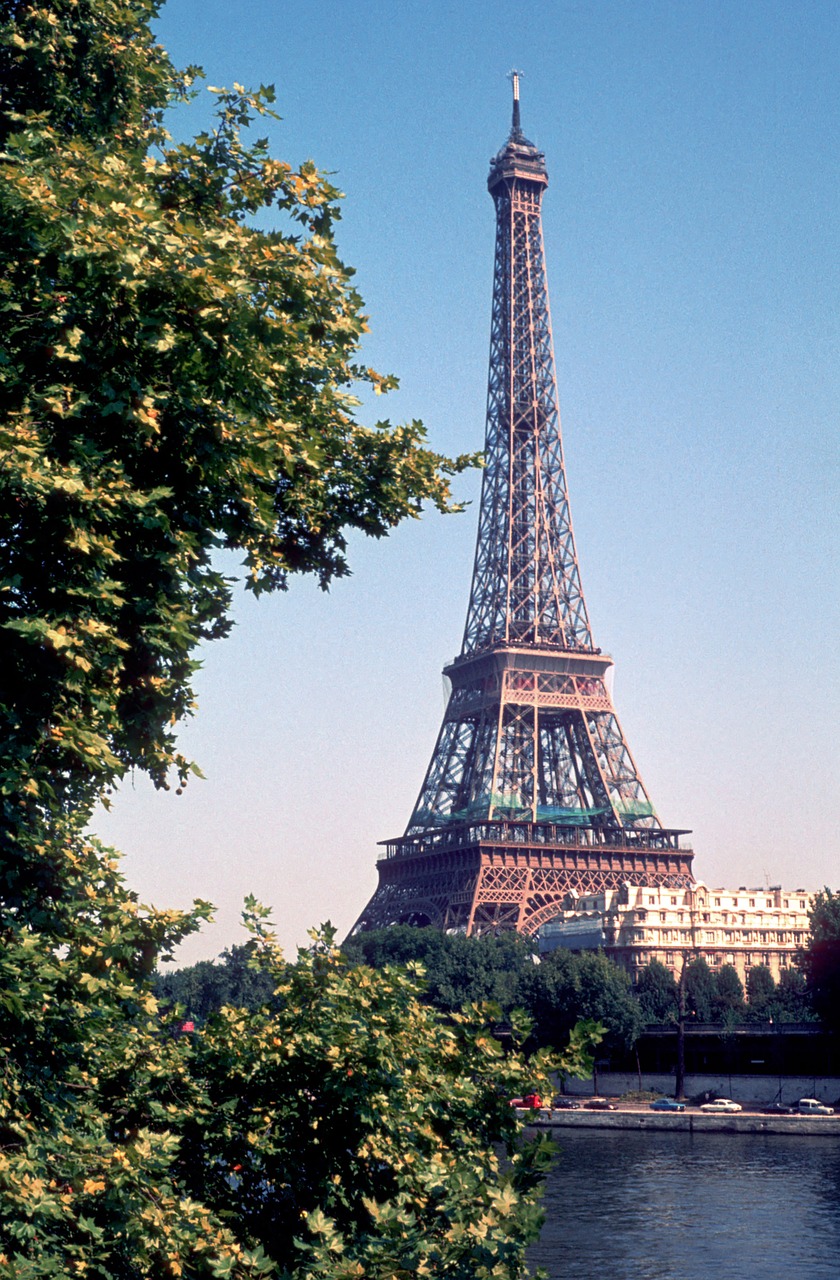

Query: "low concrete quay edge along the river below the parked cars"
(531, 1108), (840, 1138)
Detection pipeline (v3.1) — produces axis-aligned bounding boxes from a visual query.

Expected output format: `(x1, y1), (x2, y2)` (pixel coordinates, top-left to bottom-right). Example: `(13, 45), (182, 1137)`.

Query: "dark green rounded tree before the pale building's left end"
(528, 947), (642, 1052)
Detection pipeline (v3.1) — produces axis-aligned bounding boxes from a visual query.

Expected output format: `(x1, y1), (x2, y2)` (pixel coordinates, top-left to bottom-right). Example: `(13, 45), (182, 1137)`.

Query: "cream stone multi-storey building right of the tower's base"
(539, 881), (814, 983)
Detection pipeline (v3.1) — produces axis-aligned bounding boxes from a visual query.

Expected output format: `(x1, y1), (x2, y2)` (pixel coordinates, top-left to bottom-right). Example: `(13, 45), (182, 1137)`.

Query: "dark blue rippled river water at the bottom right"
(529, 1129), (840, 1280)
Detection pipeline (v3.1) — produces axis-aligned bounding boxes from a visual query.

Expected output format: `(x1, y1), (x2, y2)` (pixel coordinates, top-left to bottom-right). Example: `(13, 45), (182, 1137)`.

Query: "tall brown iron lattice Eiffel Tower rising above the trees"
(352, 72), (693, 934)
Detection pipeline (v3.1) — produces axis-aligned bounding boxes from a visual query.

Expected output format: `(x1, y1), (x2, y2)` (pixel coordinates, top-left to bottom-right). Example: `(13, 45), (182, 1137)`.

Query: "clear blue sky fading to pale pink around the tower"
(97, 0), (840, 961)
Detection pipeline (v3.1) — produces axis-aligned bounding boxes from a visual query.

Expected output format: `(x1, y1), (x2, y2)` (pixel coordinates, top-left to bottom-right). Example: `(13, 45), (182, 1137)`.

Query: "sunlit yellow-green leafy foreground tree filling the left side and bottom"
(0, 0), (584, 1280)
